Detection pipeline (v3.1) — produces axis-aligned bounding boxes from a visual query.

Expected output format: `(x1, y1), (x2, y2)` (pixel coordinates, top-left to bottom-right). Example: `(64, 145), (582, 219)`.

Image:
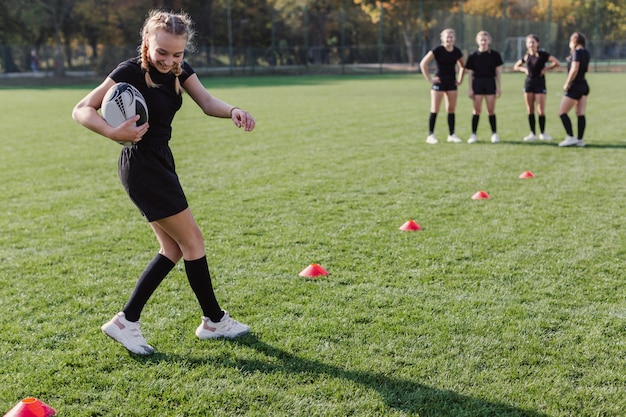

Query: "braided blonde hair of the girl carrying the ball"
(140, 10), (194, 94)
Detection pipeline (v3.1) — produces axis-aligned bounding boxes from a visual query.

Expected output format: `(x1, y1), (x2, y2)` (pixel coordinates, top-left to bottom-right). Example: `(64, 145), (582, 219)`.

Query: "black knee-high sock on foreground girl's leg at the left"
(122, 253), (176, 321)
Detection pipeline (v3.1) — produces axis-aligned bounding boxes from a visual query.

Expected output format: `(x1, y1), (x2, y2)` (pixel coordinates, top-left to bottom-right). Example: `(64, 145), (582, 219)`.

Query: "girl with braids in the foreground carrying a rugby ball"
(72, 10), (255, 355)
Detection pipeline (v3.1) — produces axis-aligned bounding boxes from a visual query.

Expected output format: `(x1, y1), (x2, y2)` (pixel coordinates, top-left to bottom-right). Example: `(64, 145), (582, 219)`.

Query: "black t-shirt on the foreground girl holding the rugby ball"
(109, 57), (195, 145)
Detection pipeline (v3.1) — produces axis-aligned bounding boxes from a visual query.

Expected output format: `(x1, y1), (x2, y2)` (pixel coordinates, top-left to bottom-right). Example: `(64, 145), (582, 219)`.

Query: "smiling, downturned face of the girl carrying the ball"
(146, 30), (187, 74)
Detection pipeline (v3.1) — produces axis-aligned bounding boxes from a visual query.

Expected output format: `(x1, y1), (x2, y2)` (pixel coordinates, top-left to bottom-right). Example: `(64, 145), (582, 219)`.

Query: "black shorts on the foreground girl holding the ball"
(118, 143), (188, 222)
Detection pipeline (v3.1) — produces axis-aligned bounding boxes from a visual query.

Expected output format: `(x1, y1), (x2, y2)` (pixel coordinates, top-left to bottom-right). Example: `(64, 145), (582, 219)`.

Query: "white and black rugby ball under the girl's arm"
(102, 83), (148, 145)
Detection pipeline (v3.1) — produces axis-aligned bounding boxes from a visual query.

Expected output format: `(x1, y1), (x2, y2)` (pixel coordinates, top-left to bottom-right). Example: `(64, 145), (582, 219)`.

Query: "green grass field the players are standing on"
(0, 73), (626, 417)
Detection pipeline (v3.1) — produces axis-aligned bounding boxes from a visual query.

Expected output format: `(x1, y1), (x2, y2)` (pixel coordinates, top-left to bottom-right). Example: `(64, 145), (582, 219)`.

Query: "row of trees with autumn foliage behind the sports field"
(0, 0), (626, 75)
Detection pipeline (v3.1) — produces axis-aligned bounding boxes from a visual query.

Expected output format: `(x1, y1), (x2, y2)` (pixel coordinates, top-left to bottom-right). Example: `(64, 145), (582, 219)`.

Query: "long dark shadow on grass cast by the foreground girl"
(144, 335), (547, 417)
